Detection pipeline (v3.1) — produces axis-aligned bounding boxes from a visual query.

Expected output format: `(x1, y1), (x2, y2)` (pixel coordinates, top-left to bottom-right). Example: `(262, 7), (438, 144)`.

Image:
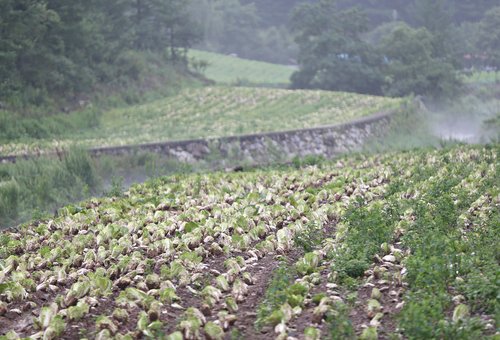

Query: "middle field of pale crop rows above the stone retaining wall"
(0, 87), (401, 155)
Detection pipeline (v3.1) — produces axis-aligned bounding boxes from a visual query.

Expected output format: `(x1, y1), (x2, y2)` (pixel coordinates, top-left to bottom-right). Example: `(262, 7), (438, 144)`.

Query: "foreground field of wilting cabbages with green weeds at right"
(0, 144), (500, 339)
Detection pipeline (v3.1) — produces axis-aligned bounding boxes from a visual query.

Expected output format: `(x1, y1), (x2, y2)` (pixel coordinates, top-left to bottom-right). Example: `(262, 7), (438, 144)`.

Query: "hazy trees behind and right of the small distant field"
(193, 0), (500, 96)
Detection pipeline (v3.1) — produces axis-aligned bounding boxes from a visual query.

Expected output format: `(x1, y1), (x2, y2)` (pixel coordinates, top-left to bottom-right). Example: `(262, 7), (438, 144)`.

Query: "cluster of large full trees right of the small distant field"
(292, 1), (466, 96)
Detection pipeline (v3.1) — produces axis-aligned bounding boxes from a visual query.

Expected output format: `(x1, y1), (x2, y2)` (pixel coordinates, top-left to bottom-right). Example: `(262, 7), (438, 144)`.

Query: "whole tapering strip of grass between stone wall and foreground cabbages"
(0, 148), (200, 229)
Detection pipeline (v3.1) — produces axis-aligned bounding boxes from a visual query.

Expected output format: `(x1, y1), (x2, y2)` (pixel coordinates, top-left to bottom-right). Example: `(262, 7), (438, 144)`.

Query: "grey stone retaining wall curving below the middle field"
(89, 113), (391, 163)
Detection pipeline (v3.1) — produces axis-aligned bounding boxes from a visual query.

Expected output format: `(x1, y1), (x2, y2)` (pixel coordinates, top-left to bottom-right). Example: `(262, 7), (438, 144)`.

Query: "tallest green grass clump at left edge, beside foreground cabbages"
(0, 149), (100, 227)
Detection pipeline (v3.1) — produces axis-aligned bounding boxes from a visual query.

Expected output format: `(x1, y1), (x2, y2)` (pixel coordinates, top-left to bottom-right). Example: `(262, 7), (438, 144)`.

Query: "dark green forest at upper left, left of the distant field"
(0, 0), (199, 109)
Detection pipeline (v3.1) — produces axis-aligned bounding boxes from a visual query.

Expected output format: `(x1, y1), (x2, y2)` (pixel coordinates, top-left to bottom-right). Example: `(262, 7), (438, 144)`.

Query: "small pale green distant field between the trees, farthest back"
(188, 50), (295, 86)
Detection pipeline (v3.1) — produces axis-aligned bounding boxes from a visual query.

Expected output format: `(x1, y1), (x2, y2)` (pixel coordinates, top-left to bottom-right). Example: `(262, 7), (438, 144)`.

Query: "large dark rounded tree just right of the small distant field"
(292, 0), (383, 94)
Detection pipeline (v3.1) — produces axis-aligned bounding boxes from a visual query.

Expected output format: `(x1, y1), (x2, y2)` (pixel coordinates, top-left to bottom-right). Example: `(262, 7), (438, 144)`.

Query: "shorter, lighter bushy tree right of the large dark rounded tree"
(381, 24), (459, 97)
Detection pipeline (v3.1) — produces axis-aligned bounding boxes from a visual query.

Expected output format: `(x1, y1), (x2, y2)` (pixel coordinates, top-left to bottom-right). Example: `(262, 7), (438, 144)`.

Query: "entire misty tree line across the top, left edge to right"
(0, 0), (500, 109)
